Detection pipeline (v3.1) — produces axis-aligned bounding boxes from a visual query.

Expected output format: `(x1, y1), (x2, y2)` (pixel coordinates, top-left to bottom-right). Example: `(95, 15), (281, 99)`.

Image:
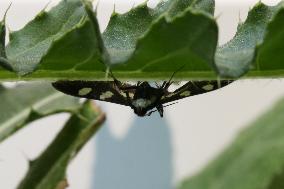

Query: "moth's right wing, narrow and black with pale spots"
(161, 80), (233, 104)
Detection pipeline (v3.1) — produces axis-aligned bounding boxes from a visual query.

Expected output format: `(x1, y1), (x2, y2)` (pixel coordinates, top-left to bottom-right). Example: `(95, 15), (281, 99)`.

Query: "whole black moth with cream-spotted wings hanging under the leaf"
(52, 74), (232, 117)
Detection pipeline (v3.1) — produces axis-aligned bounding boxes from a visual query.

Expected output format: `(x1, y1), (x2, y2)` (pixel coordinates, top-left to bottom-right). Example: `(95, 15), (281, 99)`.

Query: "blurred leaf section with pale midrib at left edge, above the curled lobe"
(0, 82), (80, 142)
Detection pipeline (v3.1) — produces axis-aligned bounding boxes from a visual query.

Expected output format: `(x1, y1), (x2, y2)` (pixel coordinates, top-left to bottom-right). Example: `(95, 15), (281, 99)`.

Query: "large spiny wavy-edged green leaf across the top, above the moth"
(0, 0), (284, 80)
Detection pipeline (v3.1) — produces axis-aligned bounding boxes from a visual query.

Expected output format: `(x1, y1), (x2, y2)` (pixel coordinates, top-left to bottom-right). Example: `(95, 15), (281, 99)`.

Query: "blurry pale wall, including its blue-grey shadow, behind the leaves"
(0, 0), (284, 189)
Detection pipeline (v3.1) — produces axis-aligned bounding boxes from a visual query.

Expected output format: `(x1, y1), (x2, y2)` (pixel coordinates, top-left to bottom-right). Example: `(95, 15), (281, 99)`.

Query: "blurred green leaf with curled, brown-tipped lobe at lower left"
(0, 82), (105, 189)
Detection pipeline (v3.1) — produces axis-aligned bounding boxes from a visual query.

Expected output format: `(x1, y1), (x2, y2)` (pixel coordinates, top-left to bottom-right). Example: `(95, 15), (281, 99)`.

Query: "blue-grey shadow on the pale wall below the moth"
(92, 115), (173, 189)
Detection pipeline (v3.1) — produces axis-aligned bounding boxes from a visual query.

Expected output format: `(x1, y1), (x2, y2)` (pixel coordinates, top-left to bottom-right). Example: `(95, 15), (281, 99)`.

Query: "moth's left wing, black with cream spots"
(52, 81), (134, 106)
